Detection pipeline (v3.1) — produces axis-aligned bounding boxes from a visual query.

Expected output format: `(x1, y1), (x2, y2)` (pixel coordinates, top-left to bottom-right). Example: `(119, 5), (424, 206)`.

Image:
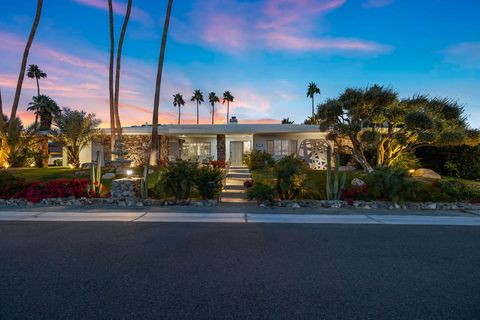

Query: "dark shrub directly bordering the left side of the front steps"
(194, 167), (223, 199)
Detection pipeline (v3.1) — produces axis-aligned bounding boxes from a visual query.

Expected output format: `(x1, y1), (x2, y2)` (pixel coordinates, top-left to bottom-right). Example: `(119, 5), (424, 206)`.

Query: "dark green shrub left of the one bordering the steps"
(153, 160), (196, 200)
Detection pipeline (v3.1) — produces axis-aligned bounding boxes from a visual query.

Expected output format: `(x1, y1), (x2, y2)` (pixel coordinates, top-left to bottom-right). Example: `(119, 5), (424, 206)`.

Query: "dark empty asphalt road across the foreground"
(0, 222), (480, 320)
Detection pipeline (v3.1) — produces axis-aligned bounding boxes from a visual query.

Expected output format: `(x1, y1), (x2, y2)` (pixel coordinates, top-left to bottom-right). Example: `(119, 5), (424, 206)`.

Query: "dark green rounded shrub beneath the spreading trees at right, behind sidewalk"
(366, 168), (416, 202)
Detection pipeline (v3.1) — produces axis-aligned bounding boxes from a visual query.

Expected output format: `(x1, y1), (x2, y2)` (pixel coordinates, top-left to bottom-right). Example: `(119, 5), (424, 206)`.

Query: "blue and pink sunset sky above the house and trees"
(0, 0), (480, 127)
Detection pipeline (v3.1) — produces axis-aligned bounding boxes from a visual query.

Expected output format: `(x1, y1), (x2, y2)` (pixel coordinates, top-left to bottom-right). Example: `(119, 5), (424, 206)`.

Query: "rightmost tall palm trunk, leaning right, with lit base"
(150, 0), (173, 166)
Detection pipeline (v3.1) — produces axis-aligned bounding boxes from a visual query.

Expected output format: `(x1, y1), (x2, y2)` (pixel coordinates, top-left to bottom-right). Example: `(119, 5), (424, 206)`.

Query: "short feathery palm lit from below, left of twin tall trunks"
(52, 108), (101, 168)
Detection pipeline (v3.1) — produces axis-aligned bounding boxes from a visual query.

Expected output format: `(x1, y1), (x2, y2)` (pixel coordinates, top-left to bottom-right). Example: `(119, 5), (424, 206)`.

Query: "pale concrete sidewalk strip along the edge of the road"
(0, 211), (480, 226)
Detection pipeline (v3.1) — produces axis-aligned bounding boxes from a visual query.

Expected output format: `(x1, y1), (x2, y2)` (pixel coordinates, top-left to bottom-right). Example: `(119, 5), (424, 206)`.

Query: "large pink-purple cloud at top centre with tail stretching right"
(173, 0), (391, 54)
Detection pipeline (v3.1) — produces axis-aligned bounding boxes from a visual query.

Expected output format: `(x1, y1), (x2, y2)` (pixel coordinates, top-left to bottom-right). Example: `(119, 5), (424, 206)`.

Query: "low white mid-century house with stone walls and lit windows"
(80, 123), (336, 169)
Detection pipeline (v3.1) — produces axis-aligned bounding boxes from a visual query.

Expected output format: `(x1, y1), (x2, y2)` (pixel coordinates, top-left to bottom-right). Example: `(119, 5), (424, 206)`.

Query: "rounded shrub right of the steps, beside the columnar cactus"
(274, 155), (308, 200)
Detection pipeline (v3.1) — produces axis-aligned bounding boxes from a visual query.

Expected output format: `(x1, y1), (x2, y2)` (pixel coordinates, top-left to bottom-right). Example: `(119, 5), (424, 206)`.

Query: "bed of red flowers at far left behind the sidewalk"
(13, 179), (90, 203)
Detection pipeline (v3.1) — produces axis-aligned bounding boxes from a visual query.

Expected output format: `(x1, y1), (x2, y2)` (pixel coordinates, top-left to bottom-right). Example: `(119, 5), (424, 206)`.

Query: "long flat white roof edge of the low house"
(109, 123), (320, 135)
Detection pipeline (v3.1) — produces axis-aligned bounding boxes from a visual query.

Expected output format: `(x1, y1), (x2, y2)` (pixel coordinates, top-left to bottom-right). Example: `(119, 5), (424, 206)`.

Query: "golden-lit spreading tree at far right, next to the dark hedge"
(374, 95), (473, 166)
